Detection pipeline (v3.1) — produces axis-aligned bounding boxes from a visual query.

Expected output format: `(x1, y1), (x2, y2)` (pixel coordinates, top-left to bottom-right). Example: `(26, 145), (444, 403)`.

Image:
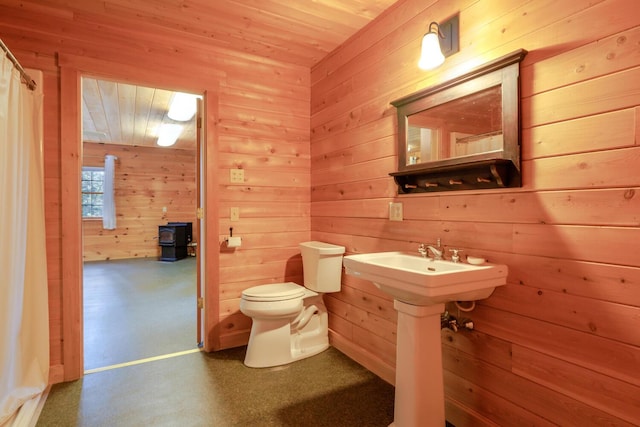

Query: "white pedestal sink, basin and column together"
(343, 252), (508, 427)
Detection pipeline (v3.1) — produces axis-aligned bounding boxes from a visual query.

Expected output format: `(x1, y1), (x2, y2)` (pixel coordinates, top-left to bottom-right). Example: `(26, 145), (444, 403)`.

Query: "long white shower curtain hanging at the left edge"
(0, 52), (49, 426)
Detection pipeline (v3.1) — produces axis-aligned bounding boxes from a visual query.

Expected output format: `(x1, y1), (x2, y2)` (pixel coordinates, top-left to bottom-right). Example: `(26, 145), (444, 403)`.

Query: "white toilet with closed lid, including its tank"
(240, 241), (344, 368)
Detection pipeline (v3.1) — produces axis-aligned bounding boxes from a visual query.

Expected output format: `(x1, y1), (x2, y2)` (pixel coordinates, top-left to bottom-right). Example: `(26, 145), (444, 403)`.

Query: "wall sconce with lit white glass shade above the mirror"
(418, 15), (460, 70)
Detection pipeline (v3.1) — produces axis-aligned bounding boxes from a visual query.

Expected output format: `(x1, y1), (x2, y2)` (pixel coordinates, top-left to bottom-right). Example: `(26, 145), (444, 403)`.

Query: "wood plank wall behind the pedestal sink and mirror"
(311, 0), (640, 427)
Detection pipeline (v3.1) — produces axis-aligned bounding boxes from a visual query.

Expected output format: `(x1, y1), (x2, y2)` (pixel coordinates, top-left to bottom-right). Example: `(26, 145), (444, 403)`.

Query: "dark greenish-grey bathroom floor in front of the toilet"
(37, 347), (394, 427)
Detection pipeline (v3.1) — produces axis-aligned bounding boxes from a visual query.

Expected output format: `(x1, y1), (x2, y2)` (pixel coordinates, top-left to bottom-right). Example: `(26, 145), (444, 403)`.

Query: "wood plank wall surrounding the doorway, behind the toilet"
(0, 1), (310, 382)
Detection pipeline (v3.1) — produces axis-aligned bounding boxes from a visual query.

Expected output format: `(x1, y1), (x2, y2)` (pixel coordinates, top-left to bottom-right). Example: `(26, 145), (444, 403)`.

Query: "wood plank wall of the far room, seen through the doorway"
(82, 142), (197, 261)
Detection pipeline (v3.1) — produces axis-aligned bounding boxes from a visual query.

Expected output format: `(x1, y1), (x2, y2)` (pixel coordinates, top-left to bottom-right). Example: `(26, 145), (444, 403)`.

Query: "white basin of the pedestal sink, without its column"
(343, 252), (508, 306)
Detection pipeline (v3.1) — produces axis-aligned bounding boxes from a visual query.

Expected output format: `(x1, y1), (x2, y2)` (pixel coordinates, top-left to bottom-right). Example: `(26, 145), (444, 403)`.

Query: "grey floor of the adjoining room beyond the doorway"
(83, 257), (197, 370)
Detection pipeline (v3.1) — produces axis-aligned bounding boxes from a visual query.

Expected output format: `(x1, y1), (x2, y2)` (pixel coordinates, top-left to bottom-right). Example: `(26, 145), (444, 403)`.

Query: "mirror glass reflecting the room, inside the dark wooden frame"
(406, 85), (504, 165)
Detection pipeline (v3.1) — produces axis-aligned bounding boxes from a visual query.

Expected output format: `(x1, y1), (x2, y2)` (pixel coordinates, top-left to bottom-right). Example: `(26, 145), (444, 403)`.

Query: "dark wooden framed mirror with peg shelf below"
(390, 49), (527, 194)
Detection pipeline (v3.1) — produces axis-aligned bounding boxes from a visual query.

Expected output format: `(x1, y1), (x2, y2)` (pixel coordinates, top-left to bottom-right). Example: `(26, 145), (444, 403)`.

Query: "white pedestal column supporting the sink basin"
(391, 300), (445, 427)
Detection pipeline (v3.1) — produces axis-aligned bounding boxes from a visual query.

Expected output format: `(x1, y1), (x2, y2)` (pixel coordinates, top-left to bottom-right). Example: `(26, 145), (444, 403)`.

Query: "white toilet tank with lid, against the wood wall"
(300, 241), (344, 293)
